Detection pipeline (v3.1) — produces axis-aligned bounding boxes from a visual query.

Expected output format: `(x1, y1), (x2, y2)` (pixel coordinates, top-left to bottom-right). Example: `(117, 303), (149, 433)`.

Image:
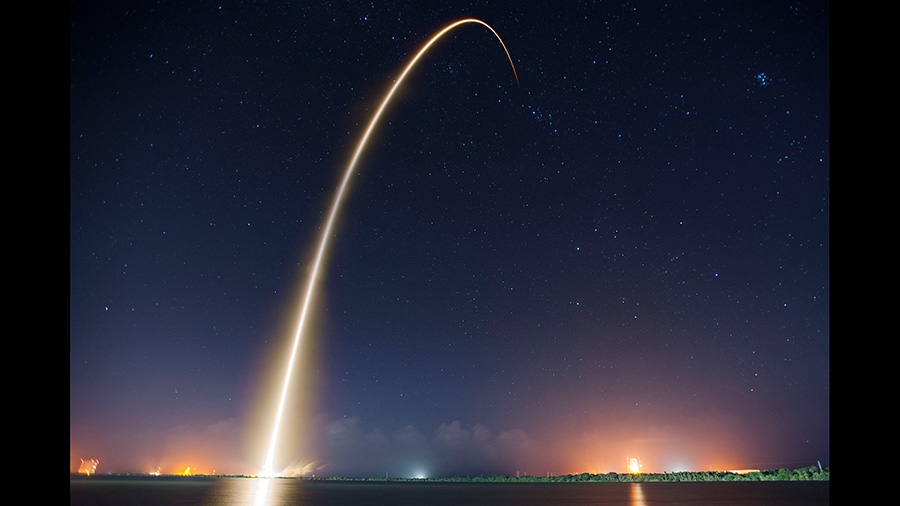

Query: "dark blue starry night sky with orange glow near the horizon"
(69, 0), (830, 477)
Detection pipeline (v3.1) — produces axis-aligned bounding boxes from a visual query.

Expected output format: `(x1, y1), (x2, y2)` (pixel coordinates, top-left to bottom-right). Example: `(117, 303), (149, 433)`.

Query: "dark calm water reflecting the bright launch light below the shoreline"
(69, 476), (829, 506)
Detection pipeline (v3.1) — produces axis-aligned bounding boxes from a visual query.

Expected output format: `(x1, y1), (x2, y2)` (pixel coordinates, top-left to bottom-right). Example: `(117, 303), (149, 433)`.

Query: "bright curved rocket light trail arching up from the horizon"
(260, 18), (519, 477)
